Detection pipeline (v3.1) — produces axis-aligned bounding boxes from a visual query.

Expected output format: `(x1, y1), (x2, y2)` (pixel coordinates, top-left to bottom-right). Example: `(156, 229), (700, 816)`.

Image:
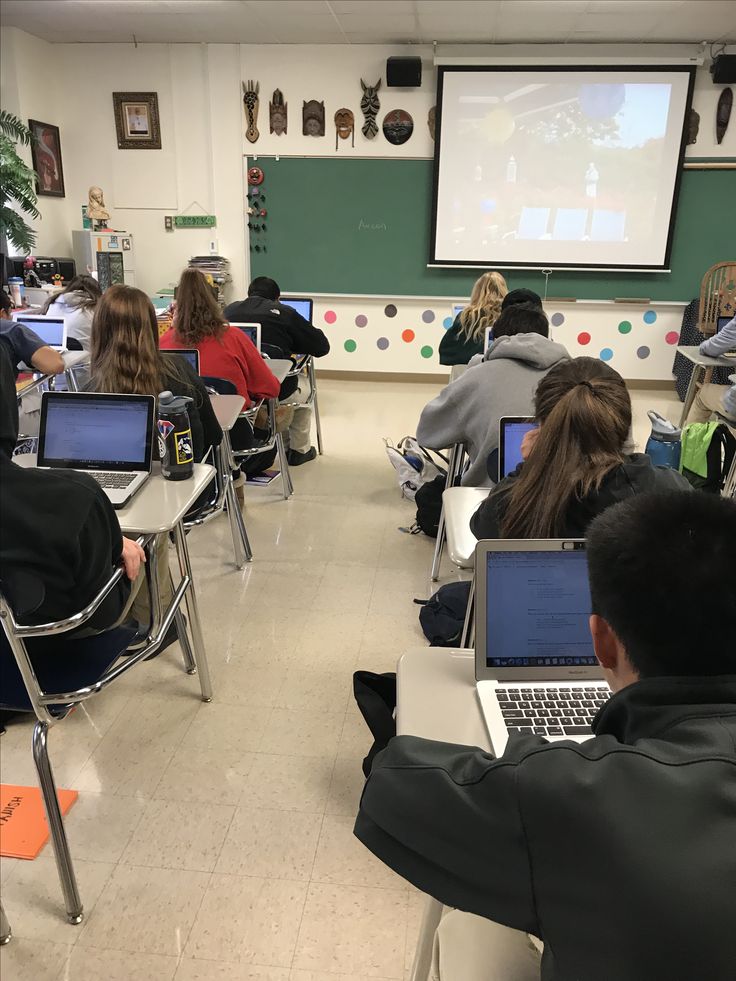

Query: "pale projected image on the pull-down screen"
(430, 67), (692, 269)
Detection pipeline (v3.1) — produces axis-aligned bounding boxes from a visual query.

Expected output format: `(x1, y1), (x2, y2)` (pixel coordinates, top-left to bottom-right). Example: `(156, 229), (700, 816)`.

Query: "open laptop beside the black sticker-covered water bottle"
(38, 392), (156, 508)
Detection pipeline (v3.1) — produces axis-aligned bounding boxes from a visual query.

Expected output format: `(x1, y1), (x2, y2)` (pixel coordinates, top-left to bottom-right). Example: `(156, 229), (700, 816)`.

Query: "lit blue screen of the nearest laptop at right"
(485, 543), (598, 668)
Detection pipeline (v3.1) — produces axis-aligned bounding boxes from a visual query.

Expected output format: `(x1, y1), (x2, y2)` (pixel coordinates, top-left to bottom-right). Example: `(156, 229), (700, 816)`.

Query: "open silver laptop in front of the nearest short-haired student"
(475, 539), (611, 756)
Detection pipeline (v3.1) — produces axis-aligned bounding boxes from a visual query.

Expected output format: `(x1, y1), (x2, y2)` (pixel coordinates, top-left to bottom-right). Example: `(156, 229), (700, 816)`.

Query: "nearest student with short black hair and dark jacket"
(355, 493), (736, 981)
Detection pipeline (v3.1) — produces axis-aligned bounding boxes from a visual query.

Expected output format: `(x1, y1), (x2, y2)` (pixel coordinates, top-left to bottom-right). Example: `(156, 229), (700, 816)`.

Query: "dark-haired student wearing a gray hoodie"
(417, 303), (570, 487)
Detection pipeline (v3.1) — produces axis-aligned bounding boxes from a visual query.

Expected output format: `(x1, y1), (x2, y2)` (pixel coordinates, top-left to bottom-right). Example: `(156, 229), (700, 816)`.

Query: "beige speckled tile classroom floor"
(0, 380), (679, 981)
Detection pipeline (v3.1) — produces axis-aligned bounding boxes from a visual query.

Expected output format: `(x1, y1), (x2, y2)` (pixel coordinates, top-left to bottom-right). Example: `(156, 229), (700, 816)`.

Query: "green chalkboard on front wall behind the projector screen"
(250, 157), (736, 300)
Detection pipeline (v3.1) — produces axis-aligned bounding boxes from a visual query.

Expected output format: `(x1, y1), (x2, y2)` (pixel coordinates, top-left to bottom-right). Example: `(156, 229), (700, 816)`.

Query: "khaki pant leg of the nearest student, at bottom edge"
(430, 910), (542, 981)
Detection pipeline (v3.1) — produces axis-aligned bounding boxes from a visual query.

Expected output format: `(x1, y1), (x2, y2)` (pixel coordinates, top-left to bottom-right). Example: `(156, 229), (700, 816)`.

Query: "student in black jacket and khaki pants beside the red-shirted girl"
(225, 276), (330, 467)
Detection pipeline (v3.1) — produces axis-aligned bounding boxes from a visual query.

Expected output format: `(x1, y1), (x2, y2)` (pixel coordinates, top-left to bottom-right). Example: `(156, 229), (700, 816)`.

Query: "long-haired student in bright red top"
(160, 269), (280, 474)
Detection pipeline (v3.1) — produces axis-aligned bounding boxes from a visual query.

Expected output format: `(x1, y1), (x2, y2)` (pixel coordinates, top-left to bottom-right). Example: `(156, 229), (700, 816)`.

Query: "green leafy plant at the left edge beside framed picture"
(0, 109), (41, 255)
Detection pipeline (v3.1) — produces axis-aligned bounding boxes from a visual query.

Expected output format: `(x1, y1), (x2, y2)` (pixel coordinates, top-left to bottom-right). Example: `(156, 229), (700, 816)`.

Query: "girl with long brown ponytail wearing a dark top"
(470, 358), (691, 539)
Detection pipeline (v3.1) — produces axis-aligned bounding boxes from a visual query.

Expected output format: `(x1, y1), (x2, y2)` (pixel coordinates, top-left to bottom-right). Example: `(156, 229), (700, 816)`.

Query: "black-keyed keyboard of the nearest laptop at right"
(495, 685), (611, 736)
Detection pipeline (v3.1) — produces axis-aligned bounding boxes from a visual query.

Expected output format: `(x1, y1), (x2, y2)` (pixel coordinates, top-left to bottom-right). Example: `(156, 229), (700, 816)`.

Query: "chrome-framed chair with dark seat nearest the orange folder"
(0, 535), (212, 924)
